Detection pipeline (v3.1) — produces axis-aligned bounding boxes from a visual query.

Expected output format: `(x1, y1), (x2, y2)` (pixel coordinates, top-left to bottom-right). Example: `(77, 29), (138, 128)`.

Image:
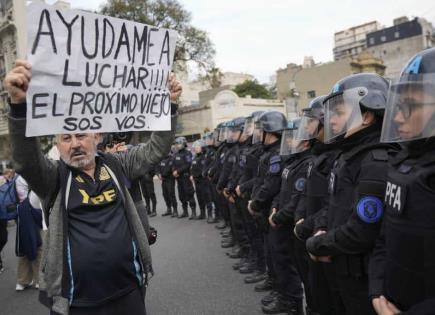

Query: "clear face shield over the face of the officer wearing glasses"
(381, 74), (435, 142)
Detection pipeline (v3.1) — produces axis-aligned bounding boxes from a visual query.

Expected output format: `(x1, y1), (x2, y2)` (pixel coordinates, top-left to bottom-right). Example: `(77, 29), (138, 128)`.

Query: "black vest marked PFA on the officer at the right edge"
(384, 150), (435, 310)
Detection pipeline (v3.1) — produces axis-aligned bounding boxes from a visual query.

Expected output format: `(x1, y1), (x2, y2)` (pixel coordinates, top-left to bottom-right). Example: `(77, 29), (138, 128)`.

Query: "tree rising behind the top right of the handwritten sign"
(100, 0), (216, 71)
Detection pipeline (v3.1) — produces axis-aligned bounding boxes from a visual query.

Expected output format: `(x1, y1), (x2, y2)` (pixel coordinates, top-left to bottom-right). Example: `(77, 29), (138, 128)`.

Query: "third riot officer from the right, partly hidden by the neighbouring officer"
(294, 96), (343, 315)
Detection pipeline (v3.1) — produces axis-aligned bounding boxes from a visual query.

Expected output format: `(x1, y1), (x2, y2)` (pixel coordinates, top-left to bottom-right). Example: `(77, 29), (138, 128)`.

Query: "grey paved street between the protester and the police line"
(0, 181), (263, 315)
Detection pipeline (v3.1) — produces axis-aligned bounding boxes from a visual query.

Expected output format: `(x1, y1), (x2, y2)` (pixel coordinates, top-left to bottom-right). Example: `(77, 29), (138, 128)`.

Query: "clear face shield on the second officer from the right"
(324, 87), (367, 143)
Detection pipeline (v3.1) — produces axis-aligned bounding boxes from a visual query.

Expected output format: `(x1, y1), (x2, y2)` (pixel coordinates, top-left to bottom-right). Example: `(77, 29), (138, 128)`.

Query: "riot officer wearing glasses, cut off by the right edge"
(369, 48), (435, 315)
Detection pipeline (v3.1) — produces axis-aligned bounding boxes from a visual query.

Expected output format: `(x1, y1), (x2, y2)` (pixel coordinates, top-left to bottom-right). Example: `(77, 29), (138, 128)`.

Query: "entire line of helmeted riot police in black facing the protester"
(162, 49), (435, 315)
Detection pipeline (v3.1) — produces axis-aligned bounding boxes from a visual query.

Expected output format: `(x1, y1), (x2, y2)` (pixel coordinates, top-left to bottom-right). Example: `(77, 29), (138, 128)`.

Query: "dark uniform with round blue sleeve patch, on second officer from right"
(307, 124), (394, 315)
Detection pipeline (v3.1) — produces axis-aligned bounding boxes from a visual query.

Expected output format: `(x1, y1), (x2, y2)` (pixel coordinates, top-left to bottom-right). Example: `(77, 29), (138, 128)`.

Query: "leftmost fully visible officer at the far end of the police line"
(172, 137), (196, 219)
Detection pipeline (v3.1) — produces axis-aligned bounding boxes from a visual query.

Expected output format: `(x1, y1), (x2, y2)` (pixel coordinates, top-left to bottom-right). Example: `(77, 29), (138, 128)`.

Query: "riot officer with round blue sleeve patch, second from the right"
(307, 73), (400, 315)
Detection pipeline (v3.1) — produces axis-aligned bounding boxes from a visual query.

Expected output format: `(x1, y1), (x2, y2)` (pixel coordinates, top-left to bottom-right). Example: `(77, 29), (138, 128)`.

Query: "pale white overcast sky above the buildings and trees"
(47, 0), (435, 82)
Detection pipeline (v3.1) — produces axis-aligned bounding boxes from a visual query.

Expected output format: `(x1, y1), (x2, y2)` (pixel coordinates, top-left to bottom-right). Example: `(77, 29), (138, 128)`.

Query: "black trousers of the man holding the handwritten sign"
(50, 289), (146, 315)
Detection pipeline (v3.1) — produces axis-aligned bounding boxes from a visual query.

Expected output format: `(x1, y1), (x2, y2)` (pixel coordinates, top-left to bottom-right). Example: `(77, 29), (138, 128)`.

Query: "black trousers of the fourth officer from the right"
(268, 227), (303, 300)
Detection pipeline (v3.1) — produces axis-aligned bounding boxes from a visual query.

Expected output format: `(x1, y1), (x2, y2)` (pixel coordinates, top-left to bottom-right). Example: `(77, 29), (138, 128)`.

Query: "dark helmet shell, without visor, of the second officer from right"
(323, 73), (389, 113)
